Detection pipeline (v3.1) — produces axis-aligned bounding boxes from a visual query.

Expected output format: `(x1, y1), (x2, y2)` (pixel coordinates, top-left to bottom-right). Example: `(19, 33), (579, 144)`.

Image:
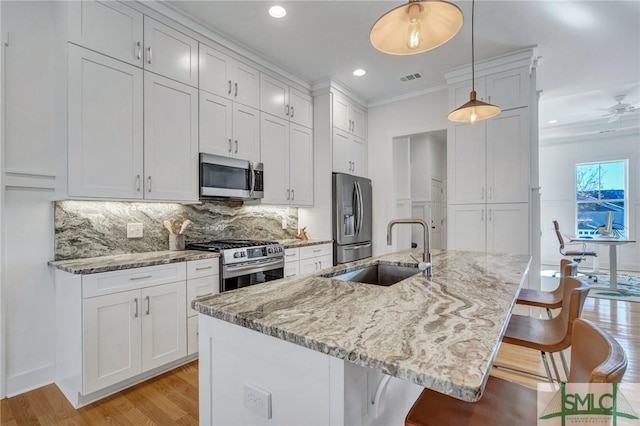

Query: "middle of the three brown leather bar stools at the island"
(502, 277), (589, 383)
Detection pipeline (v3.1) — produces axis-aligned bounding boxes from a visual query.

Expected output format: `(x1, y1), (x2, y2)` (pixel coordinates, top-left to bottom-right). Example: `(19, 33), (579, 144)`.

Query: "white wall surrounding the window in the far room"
(540, 129), (640, 271)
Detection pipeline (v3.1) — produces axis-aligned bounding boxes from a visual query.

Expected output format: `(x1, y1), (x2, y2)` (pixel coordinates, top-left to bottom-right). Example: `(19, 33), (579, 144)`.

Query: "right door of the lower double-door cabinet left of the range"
(140, 281), (187, 372)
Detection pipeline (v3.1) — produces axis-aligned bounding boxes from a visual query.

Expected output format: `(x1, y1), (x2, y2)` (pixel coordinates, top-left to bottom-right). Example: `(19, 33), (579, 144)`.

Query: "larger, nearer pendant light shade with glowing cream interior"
(369, 0), (463, 55)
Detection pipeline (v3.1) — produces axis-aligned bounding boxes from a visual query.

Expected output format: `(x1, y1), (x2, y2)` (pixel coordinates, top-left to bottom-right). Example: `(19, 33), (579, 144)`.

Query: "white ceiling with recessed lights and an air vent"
(168, 0), (640, 134)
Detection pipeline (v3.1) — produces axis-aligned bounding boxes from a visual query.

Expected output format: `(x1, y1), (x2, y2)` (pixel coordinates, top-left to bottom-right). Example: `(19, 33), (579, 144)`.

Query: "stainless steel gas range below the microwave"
(187, 240), (284, 293)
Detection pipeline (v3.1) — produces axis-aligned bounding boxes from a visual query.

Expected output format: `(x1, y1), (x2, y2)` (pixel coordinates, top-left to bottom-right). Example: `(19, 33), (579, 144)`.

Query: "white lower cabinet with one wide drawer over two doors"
(55, 259), (195, 407)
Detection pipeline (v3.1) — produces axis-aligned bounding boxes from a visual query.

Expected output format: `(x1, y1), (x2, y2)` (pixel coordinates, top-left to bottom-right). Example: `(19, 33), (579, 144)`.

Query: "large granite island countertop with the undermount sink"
(193, 249), (530, 401)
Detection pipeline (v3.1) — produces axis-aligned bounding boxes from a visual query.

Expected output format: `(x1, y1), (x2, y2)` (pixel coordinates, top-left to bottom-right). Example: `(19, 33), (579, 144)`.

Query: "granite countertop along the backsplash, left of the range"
(49, 250), (220, 275)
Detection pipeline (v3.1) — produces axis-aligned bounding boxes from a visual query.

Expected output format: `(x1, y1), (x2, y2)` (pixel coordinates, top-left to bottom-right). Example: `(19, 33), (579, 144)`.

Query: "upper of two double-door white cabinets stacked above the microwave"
(199, 43), (260, 108)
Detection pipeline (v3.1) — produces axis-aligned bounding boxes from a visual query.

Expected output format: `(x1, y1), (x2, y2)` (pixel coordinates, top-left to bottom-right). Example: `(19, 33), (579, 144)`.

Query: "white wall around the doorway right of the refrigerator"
(368, 88), (449, 256)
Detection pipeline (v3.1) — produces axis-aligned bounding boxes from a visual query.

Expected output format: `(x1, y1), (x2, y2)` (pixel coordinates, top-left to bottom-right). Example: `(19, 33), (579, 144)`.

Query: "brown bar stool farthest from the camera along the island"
(516, 259), (578, 381)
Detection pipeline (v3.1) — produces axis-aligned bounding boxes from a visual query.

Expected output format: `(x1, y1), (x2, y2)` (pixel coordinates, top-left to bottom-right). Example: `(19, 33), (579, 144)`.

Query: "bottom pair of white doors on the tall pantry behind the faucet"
(448, 203), (529, 254)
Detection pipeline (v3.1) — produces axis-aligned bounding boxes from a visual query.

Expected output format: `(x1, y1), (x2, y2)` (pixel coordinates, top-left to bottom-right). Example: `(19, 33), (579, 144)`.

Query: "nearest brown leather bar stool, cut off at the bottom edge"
(404, 319), (627, 426)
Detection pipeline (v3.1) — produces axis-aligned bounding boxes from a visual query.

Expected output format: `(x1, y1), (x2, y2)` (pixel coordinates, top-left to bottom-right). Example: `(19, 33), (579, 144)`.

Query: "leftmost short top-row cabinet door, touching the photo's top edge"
(68, 0), (142, 66)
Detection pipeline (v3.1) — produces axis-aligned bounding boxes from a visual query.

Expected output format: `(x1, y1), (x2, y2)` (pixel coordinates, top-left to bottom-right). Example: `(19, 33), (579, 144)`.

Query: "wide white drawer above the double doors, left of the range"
(82, 262), (187, 299)
